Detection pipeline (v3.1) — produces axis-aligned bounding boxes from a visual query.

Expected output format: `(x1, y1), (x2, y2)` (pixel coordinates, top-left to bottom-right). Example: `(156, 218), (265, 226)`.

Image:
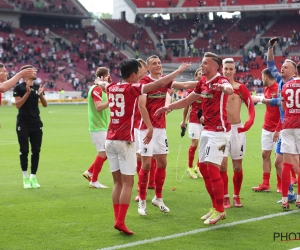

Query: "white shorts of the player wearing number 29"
(105, 140), (136, 175)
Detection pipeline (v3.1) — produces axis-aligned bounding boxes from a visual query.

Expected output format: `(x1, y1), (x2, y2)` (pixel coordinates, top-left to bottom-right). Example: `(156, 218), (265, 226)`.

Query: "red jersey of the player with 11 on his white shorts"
(194, 73), (231, 132)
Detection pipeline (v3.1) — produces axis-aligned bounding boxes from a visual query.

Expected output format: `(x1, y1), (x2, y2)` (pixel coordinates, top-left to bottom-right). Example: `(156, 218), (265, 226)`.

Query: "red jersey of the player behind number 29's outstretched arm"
(139, 75), (172, 129)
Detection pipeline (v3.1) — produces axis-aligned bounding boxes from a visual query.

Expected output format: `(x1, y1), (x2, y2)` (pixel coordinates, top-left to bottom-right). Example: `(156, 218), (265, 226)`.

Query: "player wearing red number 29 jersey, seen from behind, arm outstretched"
(105, 59), (189, 234)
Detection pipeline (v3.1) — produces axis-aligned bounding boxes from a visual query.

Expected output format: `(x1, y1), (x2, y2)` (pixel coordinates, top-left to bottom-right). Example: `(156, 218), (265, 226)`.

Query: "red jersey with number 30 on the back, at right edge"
(281, 77), (300, 129)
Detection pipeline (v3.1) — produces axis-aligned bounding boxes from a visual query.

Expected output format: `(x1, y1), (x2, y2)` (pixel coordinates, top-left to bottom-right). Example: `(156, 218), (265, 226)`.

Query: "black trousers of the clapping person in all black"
(17, 125), (43, 174)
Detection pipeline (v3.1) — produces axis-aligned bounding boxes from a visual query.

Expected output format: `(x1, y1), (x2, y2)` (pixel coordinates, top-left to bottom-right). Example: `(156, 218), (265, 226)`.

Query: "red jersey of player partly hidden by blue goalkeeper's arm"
(263, 82), (280, 132)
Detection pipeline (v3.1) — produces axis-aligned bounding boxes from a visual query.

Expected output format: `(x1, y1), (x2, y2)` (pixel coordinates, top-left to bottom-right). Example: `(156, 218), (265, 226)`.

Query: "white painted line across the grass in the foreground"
(97, 210), (300, 250)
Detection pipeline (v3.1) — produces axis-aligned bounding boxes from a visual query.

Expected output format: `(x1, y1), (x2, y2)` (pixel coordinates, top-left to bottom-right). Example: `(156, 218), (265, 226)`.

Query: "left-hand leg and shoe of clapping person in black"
(16, 126), (31, 188)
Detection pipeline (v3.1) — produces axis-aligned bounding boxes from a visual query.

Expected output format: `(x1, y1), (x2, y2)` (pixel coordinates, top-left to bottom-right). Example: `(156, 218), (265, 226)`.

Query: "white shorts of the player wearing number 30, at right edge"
(280, 128), (300, 155)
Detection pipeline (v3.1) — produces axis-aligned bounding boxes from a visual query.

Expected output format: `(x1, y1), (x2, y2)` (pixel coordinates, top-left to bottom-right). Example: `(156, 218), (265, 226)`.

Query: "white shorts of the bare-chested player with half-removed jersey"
(226, 123), (246, 160)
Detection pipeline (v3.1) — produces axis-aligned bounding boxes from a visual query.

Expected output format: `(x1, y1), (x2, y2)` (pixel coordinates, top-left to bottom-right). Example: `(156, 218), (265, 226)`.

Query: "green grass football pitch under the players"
(0, 105), (300, 250)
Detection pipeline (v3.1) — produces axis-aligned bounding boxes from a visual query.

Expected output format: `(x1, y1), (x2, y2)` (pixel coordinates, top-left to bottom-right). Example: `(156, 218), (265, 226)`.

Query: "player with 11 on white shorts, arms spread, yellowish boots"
(156, 52), (233, 224)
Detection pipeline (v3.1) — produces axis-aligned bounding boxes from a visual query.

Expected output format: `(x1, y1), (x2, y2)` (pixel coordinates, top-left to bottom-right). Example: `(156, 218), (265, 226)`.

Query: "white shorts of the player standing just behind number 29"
(139, 128), (169, 156)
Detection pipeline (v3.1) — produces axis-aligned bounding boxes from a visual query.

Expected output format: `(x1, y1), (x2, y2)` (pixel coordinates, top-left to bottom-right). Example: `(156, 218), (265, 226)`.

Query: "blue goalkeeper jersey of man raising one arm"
(267, 60), (294, 123)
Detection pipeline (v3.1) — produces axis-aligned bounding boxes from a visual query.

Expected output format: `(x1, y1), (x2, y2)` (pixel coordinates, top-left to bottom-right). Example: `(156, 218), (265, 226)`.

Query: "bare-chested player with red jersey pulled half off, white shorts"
(220, 58), (255, 208)
